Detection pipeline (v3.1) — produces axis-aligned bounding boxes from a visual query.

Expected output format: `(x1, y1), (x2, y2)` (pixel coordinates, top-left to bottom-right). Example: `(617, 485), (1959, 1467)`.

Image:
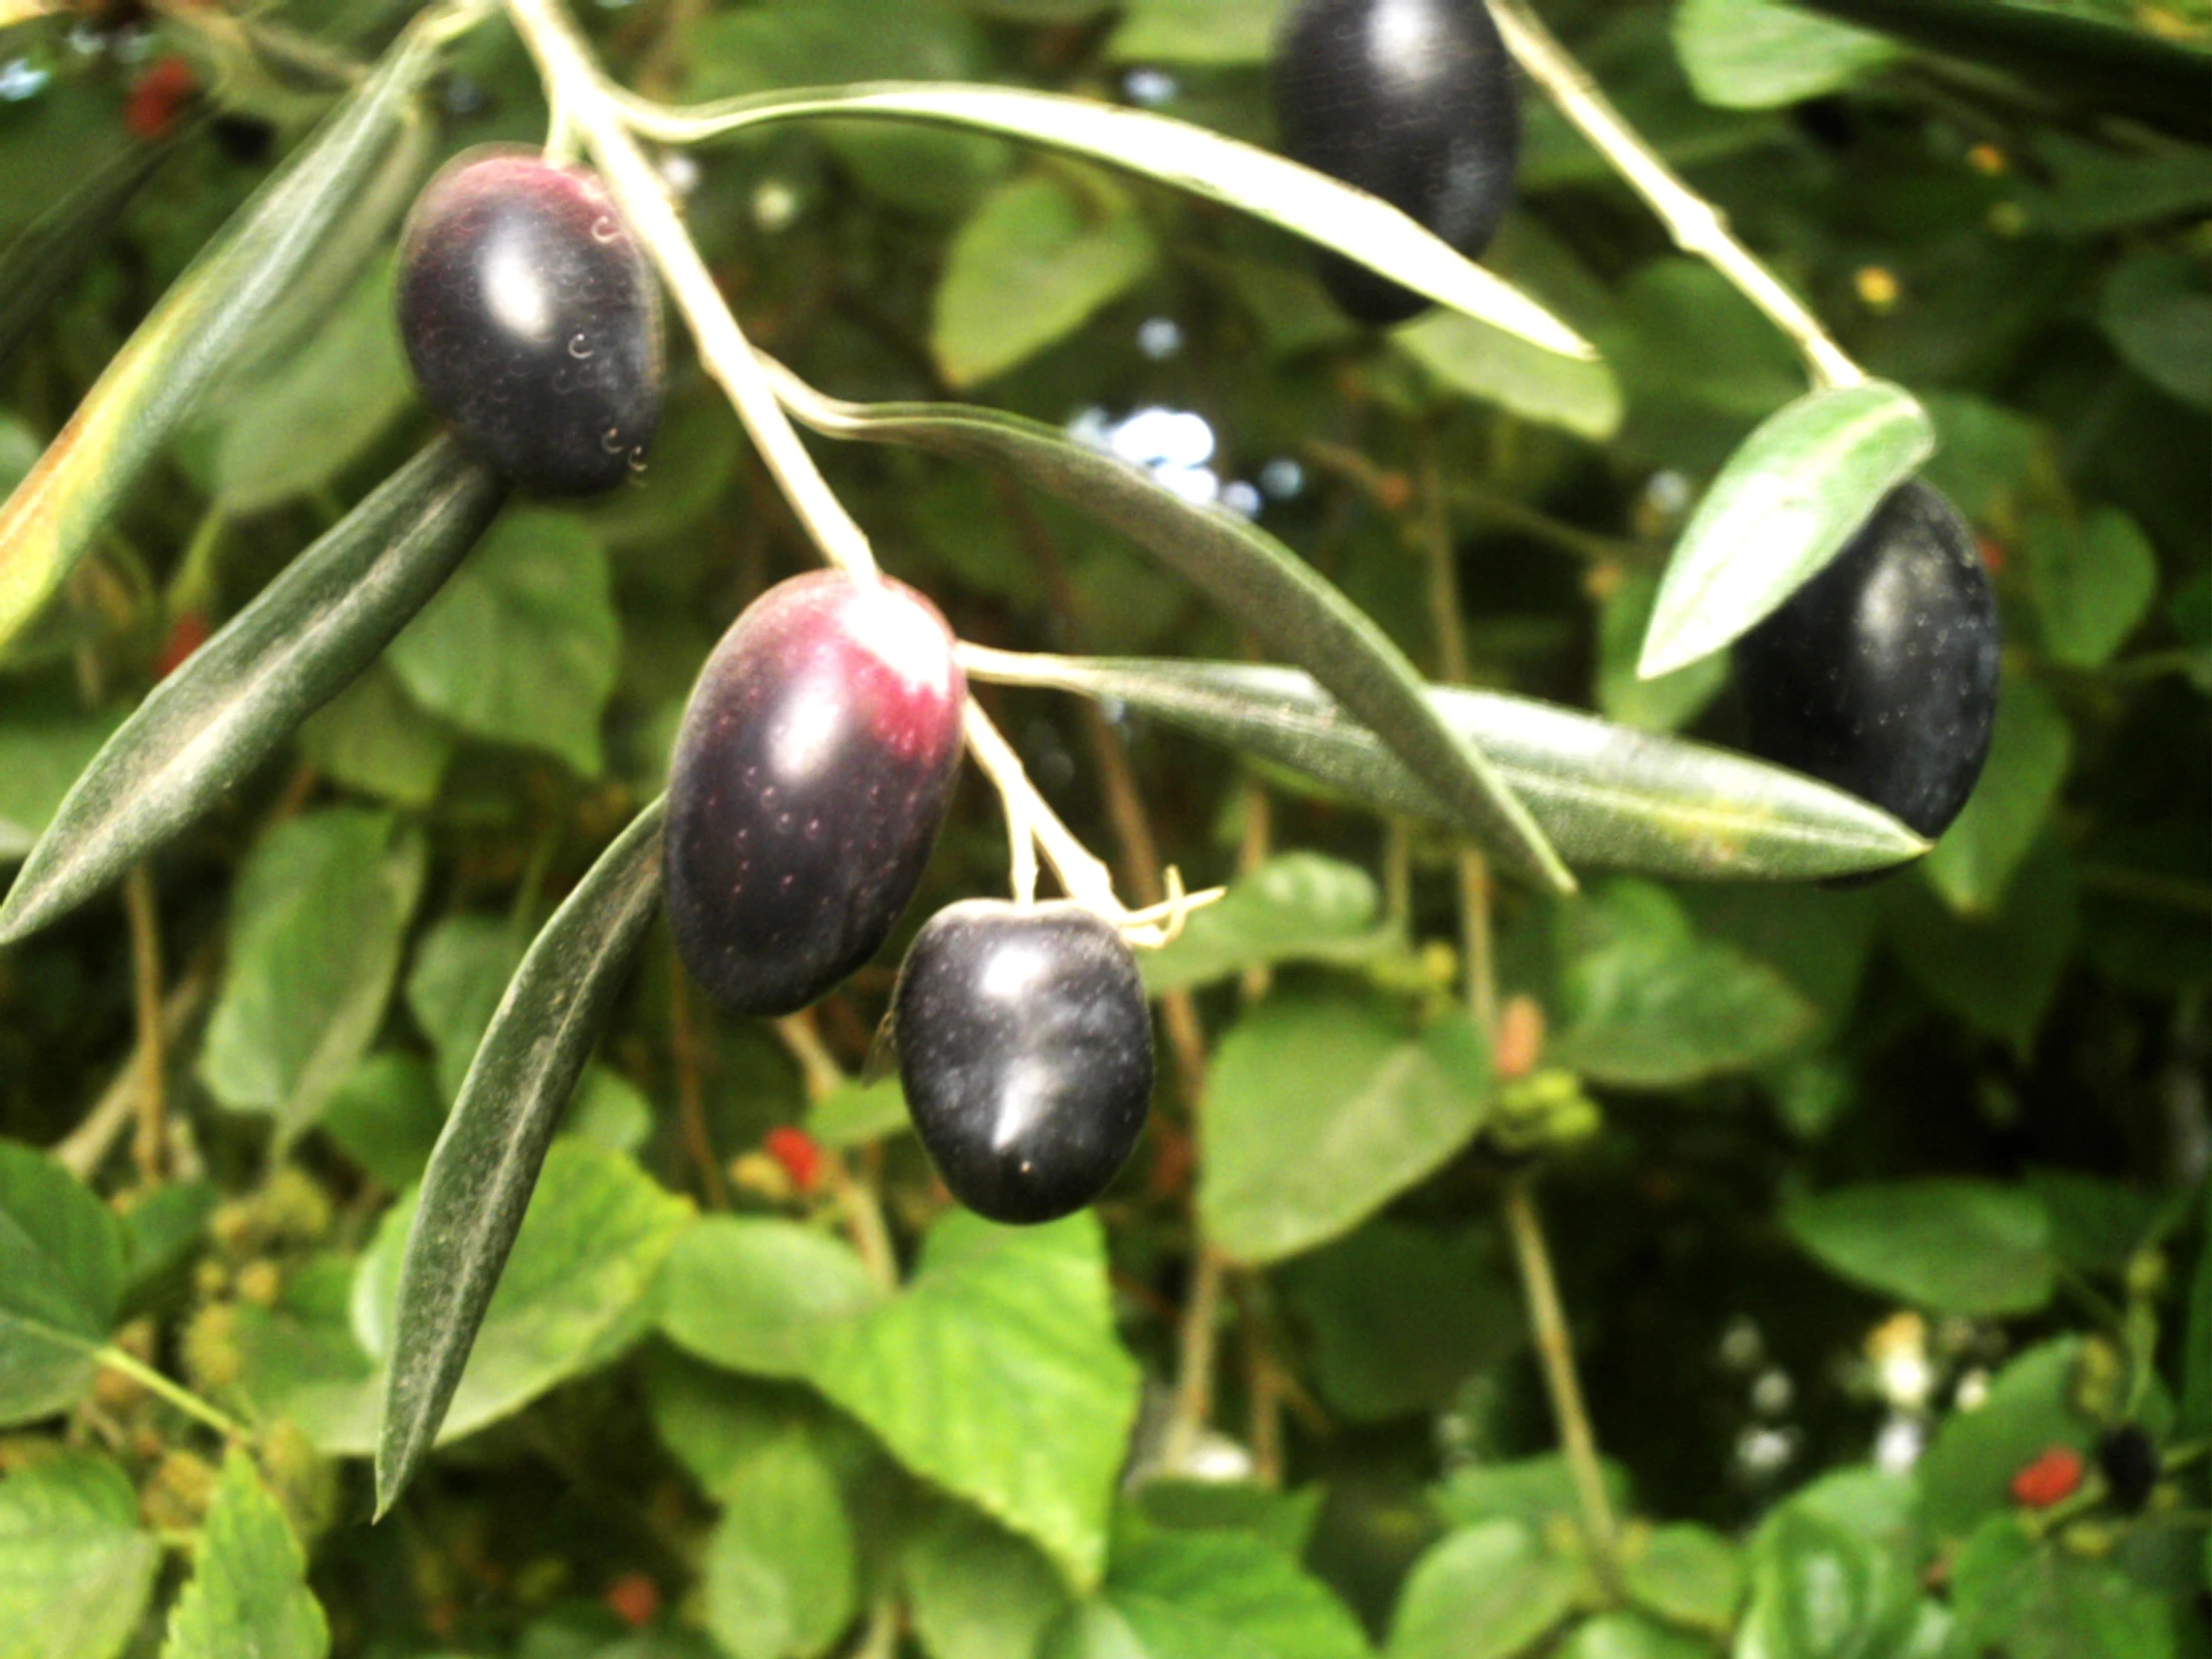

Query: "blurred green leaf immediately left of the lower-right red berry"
(1920, 1336), (2097, 1537)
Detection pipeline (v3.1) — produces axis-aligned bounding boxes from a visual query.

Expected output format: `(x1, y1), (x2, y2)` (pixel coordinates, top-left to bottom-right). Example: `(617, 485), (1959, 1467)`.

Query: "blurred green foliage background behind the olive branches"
(0, 0), (2212, 1659)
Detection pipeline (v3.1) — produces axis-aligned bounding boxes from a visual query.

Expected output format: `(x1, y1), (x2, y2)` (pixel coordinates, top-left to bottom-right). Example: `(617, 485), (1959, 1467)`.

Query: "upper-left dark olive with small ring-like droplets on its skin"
(398, 151), (664, 495)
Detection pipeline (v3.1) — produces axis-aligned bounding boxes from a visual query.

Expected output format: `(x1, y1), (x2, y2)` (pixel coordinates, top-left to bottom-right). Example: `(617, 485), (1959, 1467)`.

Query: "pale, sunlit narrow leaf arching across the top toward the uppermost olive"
(633, 82), (1597, 360)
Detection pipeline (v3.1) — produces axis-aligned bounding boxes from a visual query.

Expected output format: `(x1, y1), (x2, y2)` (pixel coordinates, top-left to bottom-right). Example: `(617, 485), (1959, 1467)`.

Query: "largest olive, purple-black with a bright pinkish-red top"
(664, 571), (966, 1013)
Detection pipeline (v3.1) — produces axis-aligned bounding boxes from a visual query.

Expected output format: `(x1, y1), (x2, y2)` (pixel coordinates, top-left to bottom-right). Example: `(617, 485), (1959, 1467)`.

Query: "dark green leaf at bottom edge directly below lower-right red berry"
(1951, 1515), (2174, 1659)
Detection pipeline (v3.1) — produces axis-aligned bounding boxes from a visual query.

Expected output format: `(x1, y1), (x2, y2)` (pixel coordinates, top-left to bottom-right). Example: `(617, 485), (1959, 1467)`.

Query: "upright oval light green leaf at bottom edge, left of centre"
(706, 1433), (858, 1659)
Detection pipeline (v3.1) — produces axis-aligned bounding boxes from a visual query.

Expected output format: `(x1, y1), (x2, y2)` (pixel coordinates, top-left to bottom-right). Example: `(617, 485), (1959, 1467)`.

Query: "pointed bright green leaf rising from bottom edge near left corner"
(162, 1446), (329, 1659)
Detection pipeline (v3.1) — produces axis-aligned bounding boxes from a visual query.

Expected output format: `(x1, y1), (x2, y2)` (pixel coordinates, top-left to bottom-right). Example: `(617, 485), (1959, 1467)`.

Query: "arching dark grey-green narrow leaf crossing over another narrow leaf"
(779, 374), (1575, 893)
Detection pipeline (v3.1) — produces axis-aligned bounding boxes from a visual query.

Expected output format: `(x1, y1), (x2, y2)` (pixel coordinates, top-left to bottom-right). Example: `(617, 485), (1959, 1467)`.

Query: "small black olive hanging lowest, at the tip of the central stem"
(891, 898), (1153, 1223)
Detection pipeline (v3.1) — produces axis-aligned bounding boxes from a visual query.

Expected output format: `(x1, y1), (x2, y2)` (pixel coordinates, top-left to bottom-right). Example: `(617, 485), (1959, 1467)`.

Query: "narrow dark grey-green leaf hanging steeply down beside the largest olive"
(376, 801), (664, 1515)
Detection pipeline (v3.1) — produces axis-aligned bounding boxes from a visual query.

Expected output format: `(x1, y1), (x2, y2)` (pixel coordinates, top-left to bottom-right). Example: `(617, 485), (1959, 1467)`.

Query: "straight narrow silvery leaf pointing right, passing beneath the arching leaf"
(966, 648), (1929, 880)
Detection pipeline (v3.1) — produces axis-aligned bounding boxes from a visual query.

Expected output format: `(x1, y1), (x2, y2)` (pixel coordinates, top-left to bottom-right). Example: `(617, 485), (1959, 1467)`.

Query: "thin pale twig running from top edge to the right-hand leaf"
(1491, 0), (1867, 387)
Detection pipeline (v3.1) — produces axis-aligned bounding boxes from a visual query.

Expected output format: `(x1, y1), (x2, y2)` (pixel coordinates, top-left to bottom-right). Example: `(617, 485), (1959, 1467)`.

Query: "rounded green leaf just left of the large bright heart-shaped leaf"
(659, 1217), (884, 1379)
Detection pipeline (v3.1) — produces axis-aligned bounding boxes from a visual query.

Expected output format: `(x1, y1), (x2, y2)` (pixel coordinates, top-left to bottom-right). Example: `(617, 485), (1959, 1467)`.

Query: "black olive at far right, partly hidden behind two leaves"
(1737, 480), (1997, 836)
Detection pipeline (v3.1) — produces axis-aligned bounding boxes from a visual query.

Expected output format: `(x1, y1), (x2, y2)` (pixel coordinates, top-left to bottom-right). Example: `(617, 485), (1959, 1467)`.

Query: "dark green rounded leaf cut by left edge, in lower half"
(0, 1141), (124, 1424)
